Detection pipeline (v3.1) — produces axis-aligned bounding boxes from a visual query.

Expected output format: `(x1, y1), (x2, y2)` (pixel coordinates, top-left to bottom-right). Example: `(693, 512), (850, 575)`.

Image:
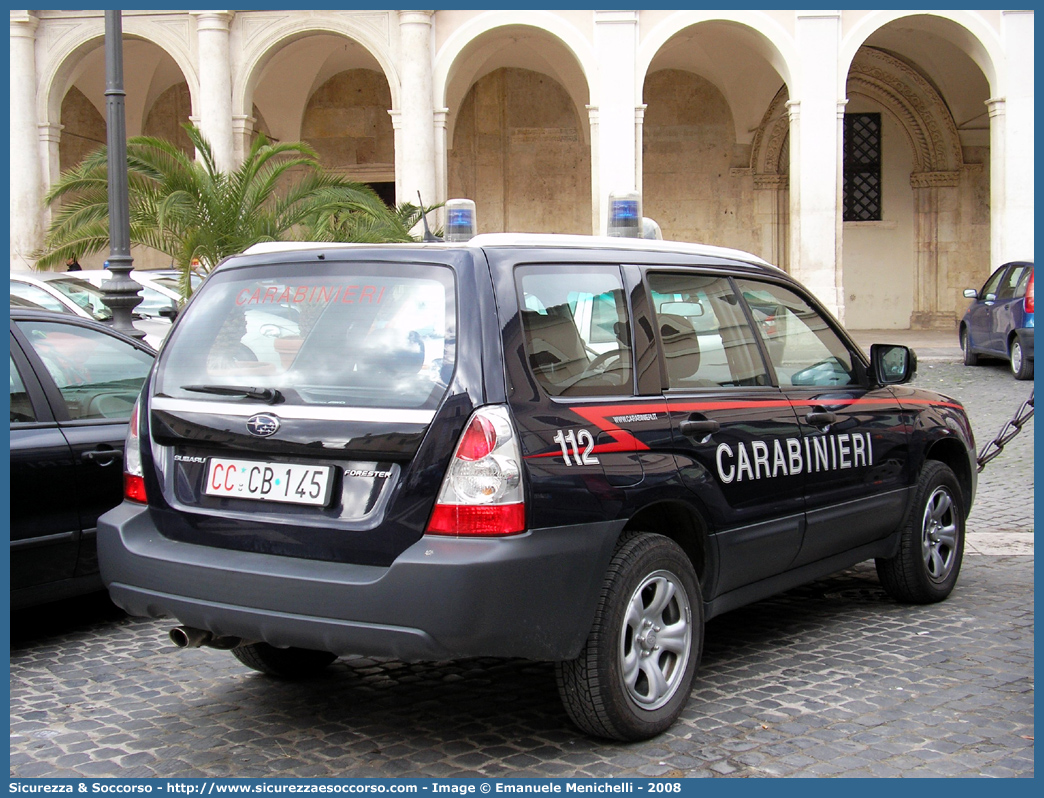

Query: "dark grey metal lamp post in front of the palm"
(101, 10), (145, 338)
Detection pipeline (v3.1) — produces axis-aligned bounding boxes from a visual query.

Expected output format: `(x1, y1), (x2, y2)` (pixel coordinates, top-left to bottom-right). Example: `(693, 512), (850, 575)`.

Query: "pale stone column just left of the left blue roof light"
(393, 11), (436, 205)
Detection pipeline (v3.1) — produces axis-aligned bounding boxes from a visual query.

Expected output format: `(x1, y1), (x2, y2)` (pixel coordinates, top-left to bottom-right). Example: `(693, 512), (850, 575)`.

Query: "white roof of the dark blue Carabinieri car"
(243, 233), (776, 268)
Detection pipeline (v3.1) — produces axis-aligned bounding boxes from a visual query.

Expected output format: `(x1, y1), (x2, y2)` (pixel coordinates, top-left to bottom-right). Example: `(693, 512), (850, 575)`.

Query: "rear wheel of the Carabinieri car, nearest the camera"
(555, 533), (704, 741)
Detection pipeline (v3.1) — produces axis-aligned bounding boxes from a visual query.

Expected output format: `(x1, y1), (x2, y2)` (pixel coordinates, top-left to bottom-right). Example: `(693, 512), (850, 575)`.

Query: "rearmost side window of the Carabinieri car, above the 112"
(515, 264), (634, 396)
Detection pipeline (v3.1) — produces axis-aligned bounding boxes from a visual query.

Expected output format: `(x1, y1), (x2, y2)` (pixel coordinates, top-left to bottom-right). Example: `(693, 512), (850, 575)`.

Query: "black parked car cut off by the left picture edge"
(10, 305), (156, 608)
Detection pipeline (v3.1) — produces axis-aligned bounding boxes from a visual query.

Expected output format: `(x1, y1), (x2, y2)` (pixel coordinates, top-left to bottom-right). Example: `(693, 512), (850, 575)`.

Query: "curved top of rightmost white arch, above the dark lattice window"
(837, 10), (1006, 97)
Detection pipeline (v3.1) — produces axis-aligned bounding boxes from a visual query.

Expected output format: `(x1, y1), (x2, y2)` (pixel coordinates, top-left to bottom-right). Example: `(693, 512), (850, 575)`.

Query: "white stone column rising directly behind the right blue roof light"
(589, 10), (642, 235)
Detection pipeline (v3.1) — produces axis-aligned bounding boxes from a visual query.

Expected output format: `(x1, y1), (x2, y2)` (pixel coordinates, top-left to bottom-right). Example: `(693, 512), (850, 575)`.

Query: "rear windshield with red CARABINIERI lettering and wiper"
(156, 263), (456, 409)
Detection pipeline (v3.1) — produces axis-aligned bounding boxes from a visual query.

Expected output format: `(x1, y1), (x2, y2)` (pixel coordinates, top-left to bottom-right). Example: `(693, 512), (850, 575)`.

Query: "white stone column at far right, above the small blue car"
(991, 10), (1035, 266)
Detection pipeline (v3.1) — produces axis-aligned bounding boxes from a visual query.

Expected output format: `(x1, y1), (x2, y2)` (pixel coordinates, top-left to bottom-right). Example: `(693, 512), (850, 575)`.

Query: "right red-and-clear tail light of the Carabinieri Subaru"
(427, 405), (525, 536)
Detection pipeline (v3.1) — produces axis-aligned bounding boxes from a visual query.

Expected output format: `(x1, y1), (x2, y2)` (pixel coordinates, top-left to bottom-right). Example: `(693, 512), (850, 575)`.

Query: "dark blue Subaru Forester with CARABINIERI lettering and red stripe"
(98, 235), (976, 740)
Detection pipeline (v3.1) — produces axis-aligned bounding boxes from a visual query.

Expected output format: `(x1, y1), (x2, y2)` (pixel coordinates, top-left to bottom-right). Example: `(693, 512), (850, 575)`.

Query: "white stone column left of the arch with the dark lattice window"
(789, 11), (845, 322)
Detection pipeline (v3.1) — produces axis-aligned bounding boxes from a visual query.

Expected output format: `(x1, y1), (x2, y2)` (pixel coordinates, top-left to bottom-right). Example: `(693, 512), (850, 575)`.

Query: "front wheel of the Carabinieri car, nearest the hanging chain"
(874, 461), (965, 604)
